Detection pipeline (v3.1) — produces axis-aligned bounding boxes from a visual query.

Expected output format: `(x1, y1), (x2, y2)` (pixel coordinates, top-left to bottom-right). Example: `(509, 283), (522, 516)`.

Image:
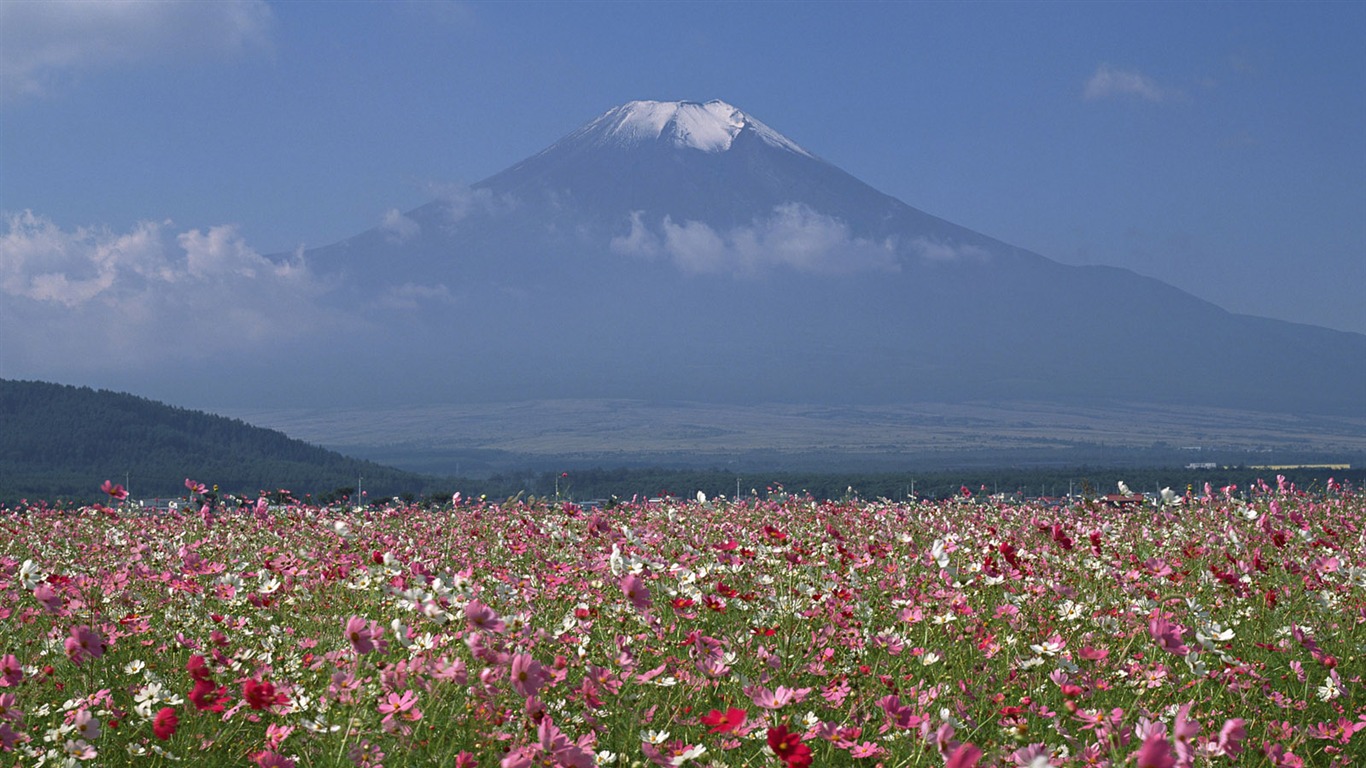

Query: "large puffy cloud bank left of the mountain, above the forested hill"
(0, 210), (339, 370)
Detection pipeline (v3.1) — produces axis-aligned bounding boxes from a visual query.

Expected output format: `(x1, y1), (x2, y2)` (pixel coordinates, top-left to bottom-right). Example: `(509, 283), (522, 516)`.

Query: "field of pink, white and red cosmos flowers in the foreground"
(0, 482), (1366, 768)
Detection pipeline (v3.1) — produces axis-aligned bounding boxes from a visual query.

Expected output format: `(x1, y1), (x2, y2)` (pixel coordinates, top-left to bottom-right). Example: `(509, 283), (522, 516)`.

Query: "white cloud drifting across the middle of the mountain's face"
(612, 202), (900, 275)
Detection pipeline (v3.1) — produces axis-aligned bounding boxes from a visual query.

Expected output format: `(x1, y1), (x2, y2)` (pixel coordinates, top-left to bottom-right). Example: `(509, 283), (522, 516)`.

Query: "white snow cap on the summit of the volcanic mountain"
(579, 100), (810, 156)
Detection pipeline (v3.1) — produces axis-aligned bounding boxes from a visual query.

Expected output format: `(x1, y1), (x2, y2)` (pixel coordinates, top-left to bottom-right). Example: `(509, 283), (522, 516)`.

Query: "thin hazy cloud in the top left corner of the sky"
(0, 0), (272, 98)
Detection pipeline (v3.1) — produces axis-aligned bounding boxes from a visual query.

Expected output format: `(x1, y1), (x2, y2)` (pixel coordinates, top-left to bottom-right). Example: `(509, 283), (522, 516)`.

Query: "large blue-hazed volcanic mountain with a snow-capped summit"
(306, 101), (1366, 414)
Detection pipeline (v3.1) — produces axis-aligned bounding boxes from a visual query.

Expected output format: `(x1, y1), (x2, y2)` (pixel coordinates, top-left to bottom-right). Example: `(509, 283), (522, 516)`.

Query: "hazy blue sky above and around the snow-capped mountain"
(0, 0), (1366, 332)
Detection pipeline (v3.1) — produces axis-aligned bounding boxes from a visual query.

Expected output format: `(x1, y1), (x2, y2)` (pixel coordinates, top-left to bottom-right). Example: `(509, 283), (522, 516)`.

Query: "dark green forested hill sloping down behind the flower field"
(0, 379), (429, 502)
